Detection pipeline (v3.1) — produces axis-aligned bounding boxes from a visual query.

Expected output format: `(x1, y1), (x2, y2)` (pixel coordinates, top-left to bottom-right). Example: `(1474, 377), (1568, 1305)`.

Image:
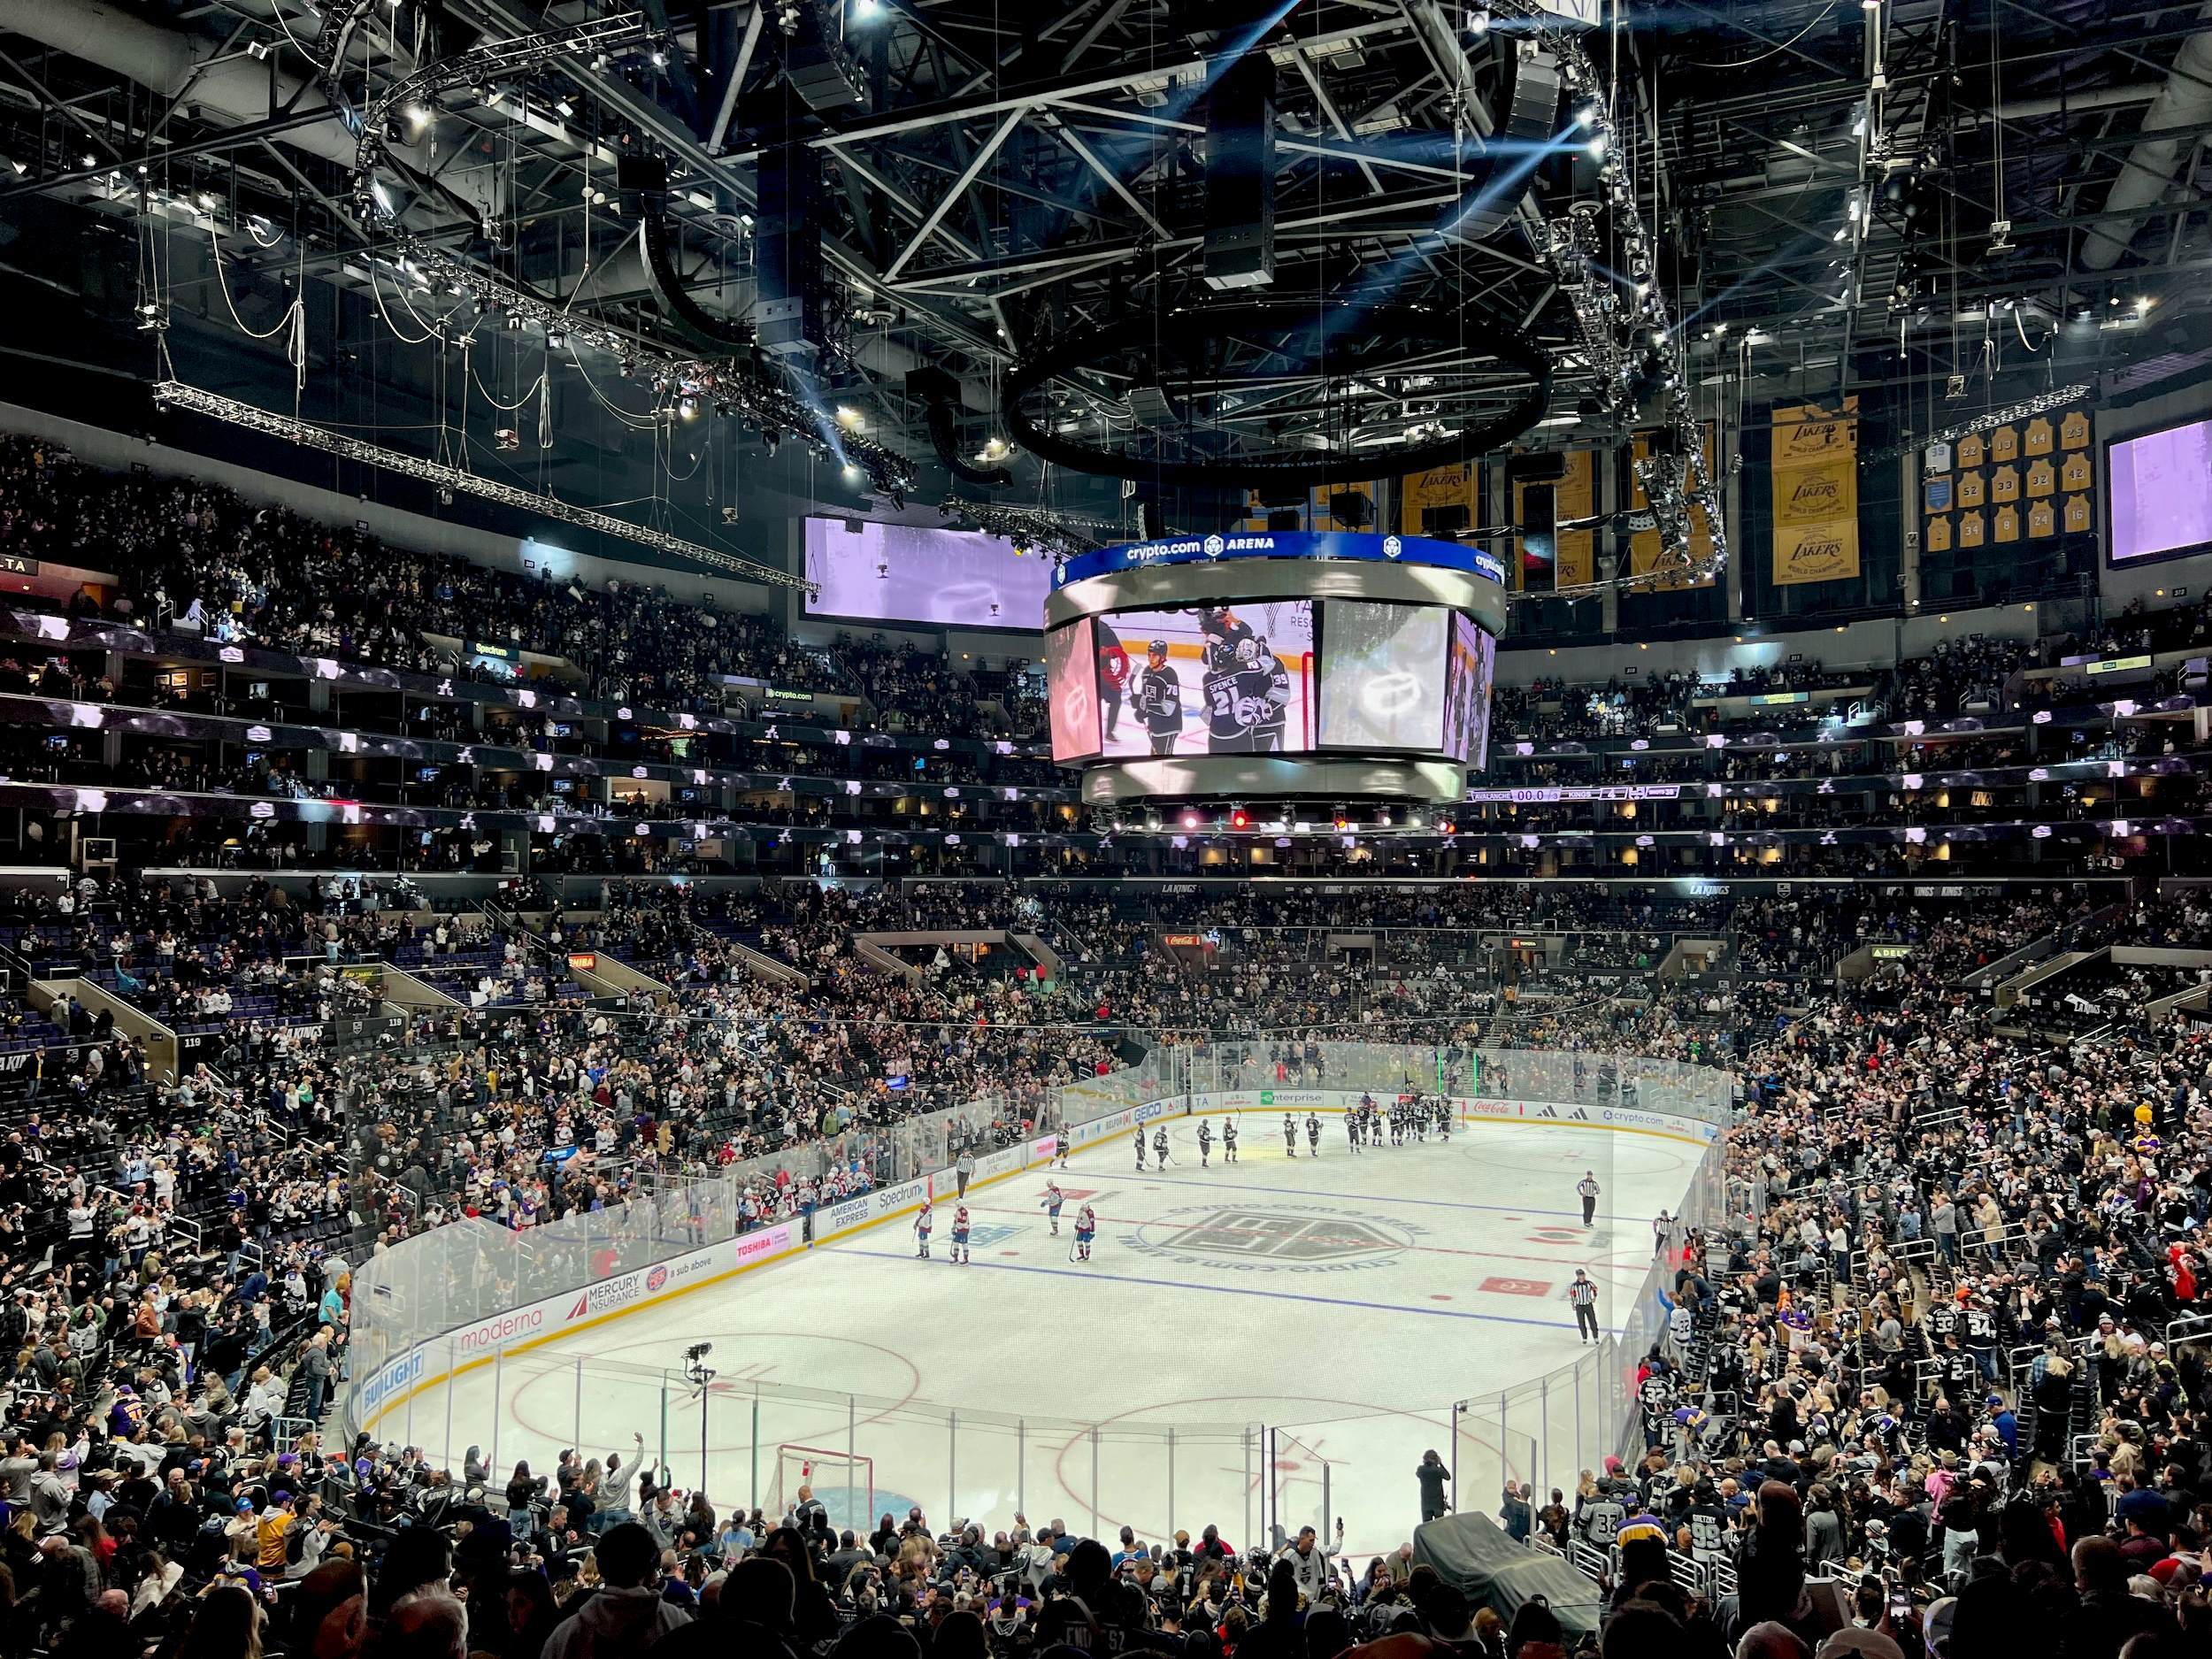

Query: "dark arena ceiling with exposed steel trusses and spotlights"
(0, 0), (2212, 541)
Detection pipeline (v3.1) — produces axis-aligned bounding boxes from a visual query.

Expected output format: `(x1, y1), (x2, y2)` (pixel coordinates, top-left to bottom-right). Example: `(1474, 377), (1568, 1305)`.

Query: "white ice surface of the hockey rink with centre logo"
(416, 1113), (1699, 1566)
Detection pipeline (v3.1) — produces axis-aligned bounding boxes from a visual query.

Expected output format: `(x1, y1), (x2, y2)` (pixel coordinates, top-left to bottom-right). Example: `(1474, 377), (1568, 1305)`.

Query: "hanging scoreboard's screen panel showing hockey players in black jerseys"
(1097, 600), (1314, 759)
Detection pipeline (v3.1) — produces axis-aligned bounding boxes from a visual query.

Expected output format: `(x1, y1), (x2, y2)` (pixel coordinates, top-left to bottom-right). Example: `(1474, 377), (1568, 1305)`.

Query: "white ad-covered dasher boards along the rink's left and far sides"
(354, 1106), (1721, 1433)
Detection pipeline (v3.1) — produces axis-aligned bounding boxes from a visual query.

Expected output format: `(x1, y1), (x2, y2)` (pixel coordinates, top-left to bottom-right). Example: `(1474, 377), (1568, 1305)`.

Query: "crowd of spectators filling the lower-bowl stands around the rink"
(0, 885), (2212, 1659)
